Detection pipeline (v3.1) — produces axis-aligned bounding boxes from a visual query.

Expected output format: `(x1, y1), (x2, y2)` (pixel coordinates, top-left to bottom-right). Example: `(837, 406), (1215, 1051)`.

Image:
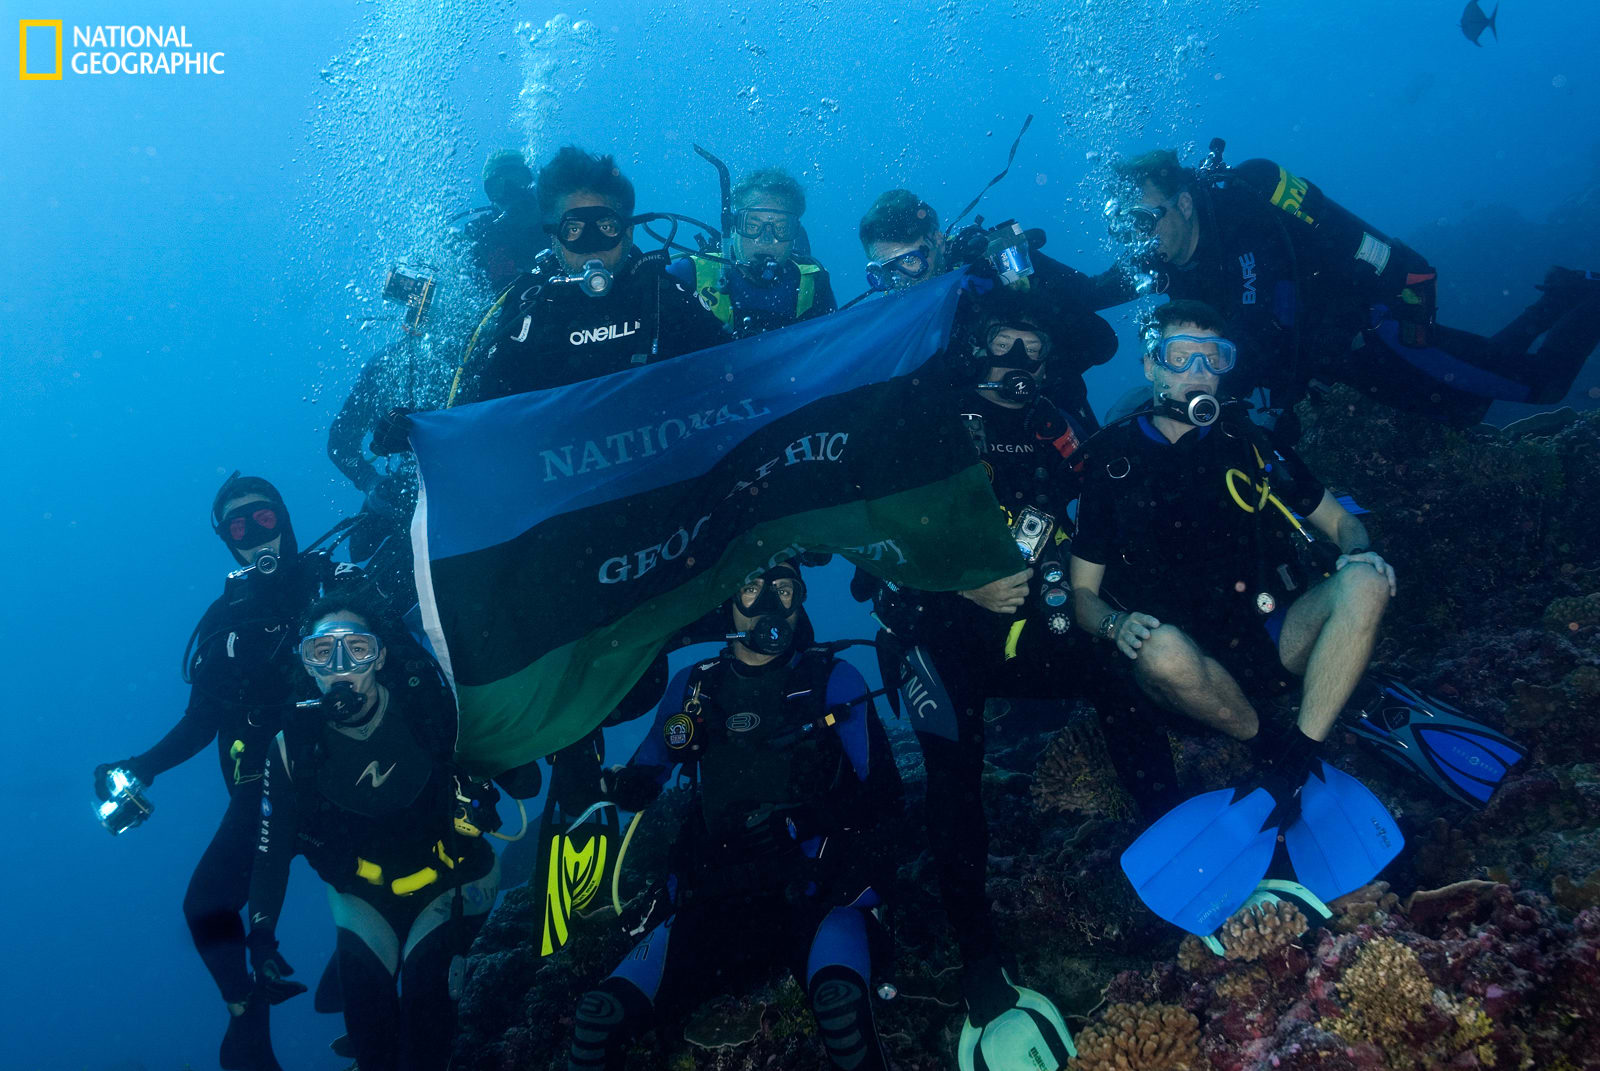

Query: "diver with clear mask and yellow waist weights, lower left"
(248, 594), (499, 1071)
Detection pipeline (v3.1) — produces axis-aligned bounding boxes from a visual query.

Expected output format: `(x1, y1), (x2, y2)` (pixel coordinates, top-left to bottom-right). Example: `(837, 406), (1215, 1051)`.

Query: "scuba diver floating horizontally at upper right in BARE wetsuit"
(1096, 139), (1600, 426)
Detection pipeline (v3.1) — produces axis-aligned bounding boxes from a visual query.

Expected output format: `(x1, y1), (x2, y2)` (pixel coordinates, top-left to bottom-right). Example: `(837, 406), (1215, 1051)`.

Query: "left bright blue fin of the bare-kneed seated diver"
(1122, 788), (1278, 937)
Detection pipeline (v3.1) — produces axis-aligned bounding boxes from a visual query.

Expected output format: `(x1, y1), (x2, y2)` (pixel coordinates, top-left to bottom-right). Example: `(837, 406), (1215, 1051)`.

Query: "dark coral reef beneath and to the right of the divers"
(456, 391), (1600, 1071)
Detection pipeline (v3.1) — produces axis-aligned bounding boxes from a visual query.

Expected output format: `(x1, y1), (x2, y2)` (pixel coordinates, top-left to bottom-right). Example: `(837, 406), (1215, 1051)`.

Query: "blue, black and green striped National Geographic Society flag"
(411, 274), (1018, 773)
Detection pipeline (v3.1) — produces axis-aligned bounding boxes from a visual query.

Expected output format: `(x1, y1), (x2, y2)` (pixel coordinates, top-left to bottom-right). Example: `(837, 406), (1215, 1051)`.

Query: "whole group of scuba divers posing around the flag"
(94, 142), (1600, 1071)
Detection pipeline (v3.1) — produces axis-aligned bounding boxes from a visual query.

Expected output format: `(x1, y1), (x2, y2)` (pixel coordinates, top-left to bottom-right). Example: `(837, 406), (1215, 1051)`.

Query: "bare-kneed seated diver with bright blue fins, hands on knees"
(1070, 301), (1403, 937)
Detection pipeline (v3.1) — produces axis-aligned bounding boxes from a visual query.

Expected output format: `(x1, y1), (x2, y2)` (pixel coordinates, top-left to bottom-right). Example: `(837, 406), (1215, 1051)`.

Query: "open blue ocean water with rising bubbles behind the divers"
(0, 0), (1600, 1071)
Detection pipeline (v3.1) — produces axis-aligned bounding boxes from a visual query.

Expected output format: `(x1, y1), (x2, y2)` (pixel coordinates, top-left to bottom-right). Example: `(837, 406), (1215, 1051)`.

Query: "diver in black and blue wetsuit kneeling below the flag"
(566, 562), (901, 1071)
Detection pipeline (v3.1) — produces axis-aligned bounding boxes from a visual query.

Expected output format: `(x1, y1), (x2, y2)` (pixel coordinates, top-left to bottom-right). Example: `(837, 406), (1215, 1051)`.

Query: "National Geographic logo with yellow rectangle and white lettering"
(18, 19), (227, 82)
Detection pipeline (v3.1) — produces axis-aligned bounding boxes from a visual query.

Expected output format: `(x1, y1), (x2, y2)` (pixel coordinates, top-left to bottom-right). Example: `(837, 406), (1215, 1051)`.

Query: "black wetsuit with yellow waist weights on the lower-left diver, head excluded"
(250, 668), (498, 1071)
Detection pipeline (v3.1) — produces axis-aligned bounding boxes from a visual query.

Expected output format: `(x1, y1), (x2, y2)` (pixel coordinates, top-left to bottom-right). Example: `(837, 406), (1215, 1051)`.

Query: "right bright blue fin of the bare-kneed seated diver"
(1283, 760), (1405, 901)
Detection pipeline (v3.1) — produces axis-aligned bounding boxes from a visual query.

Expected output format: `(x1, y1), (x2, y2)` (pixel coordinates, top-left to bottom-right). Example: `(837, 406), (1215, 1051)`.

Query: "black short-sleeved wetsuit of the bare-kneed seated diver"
(1072, 411), (1325, 698)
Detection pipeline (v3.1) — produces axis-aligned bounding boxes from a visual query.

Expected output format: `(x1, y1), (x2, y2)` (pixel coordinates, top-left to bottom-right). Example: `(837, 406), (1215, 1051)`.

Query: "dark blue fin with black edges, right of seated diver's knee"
(1349, 672), (1528, 807)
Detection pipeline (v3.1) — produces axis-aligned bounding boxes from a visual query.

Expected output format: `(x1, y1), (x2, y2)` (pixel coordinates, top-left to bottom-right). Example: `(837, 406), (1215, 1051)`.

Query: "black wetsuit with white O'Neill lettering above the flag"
(456, 250), (726, 405)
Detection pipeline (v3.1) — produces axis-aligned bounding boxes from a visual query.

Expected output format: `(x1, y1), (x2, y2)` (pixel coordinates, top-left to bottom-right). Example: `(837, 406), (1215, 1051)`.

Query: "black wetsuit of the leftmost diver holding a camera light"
(115, 556), (331, 1004)
